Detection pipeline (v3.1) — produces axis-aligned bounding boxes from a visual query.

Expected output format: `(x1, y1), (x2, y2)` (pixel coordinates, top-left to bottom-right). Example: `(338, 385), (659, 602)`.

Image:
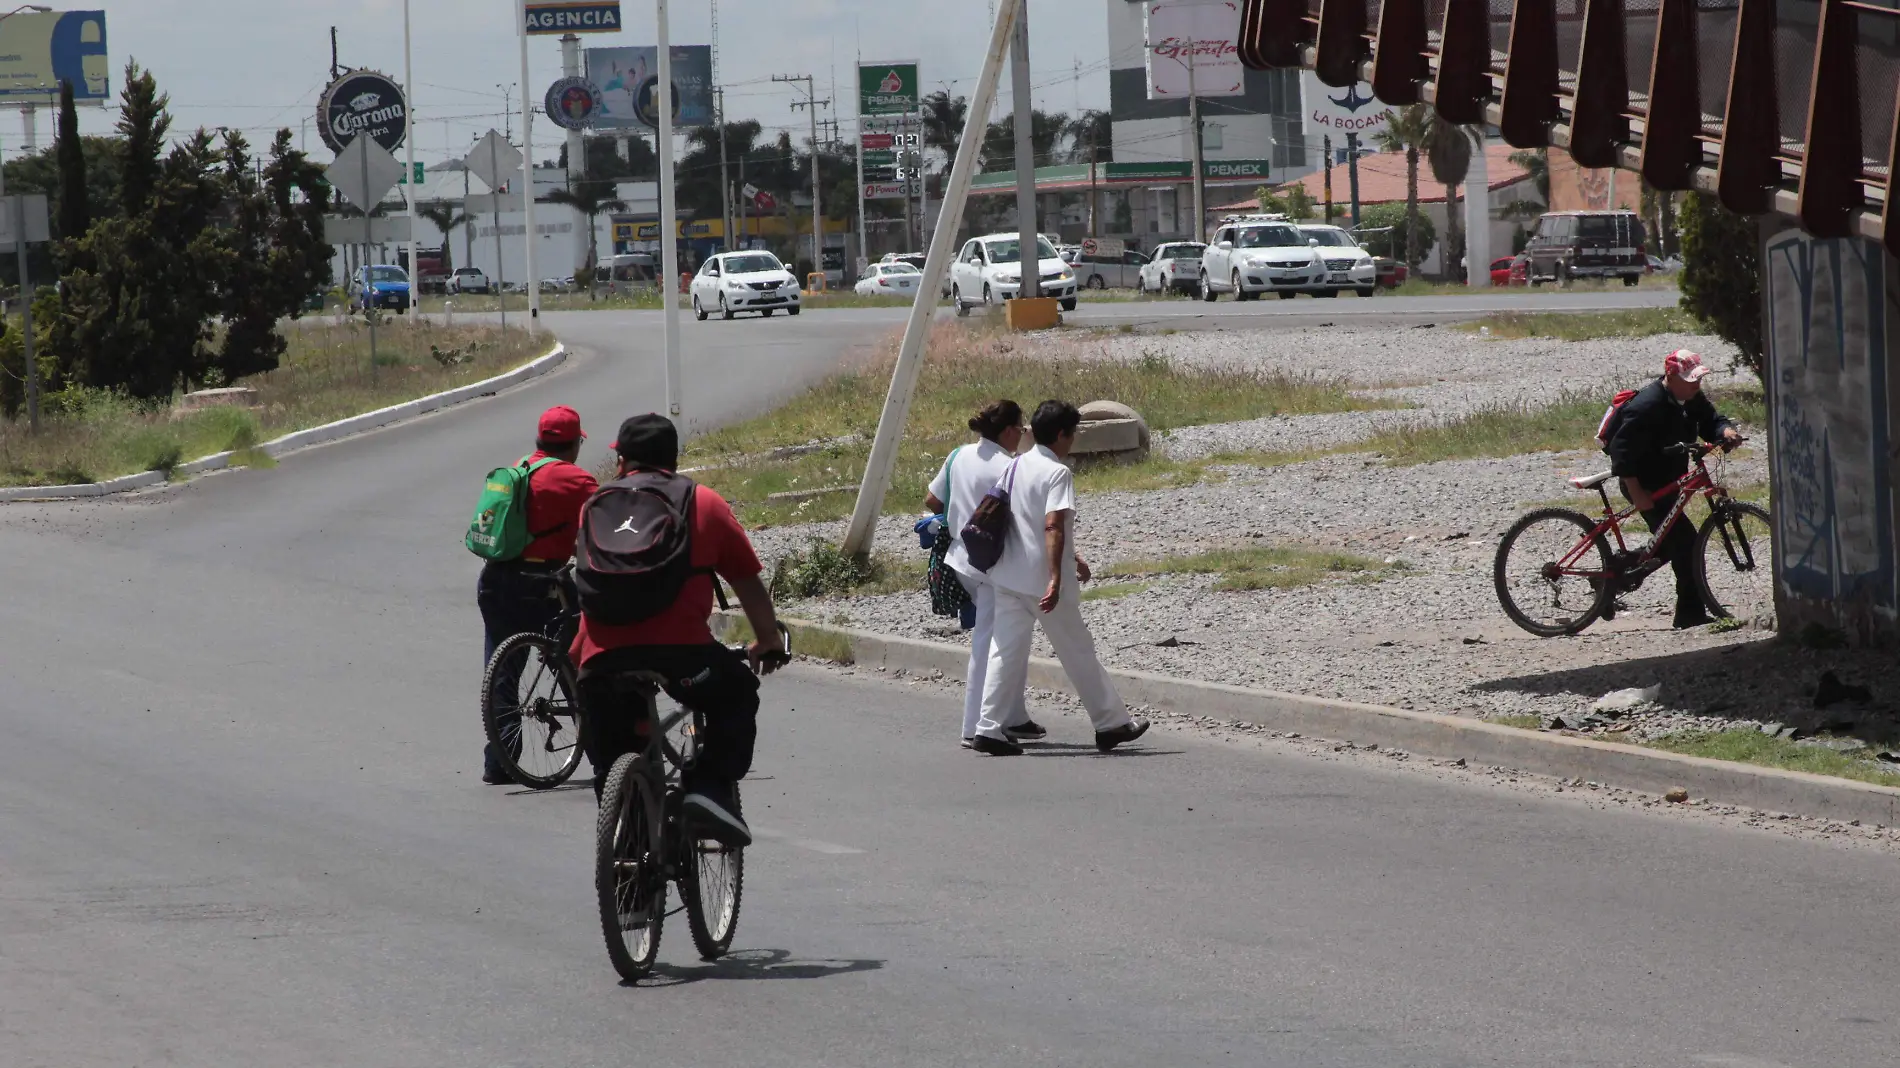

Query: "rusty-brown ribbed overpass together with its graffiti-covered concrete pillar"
(1239, 0), (1900, 644)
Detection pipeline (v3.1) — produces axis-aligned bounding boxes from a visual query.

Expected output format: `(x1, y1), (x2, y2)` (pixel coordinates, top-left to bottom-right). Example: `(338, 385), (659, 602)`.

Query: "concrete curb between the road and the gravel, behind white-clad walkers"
(733, 616), (1900, 827)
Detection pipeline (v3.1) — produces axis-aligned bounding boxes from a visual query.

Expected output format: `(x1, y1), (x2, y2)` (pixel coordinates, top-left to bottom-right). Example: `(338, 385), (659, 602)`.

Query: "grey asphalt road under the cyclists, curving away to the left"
(0, 302), (1900, 1068)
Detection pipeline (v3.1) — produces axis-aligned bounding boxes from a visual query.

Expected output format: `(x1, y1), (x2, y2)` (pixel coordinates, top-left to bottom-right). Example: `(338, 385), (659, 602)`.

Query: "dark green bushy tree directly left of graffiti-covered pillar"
(1676, 192), (1763, 378)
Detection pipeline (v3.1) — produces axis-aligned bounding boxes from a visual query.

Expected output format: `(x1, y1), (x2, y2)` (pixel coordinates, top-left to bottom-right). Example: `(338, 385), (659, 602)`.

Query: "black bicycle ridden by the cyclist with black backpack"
(595, 625), (790, 982)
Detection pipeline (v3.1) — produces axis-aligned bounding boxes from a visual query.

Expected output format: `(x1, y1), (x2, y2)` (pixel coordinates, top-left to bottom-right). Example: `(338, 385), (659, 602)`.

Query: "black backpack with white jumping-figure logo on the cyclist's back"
(574, 469), (699, 625)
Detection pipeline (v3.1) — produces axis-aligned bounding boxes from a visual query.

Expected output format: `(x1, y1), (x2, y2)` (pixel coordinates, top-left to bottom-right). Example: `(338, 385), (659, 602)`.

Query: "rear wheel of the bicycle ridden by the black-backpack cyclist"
(595, 753), (667, 982)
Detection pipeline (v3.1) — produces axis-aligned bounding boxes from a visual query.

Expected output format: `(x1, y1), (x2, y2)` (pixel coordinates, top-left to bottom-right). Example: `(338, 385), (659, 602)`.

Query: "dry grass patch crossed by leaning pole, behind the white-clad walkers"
(688, 321), (1385, 526)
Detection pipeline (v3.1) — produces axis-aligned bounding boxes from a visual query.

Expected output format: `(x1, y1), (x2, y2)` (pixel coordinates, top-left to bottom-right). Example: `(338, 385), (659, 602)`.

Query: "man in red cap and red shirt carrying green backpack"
(475, 405), (599, 787)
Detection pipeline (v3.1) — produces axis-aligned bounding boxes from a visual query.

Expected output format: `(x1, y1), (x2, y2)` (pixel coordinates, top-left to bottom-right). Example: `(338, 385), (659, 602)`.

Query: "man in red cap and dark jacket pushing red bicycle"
(1606, 348), (1742, 629)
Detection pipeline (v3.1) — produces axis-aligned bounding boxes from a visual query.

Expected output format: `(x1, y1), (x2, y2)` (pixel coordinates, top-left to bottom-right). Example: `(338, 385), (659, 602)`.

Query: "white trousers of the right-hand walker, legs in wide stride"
(977, 587), (1129, 739)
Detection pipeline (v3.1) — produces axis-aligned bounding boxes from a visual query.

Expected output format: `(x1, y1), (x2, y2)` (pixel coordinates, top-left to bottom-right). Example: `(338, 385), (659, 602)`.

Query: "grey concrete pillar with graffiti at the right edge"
(1761, 220), (1900, 644)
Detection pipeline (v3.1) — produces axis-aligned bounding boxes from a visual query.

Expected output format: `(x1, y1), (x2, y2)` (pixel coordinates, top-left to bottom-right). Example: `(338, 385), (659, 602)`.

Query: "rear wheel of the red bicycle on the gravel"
(1492, 507), (1615, 639)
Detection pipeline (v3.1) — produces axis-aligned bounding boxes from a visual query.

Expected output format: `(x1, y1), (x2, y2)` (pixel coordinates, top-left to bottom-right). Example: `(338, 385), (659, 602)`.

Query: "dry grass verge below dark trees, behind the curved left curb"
(0, 319), (551, 486)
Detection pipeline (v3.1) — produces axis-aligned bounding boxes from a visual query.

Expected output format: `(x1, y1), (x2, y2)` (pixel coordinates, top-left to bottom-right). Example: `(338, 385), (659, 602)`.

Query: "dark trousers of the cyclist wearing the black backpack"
(580, 642), (758, 802)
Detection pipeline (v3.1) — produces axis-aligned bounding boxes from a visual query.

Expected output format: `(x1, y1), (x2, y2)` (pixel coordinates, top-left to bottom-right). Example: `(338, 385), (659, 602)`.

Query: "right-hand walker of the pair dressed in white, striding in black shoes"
(971, 401), (1148, 756)
